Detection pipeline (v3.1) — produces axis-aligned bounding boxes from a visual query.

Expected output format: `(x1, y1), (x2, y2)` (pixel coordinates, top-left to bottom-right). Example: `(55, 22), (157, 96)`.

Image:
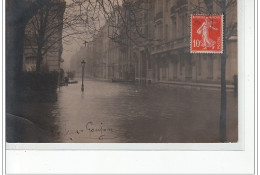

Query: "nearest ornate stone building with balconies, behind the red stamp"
(133, 0), (237, 87)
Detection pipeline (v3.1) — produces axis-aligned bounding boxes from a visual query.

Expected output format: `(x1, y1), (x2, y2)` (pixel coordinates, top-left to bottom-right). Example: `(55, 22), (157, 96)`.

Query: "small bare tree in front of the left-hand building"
(25, 0), (65, 72)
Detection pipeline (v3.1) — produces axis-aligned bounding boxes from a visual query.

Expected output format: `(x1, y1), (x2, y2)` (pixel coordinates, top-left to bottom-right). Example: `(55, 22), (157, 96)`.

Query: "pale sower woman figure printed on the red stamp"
(197, 17), (218, 49)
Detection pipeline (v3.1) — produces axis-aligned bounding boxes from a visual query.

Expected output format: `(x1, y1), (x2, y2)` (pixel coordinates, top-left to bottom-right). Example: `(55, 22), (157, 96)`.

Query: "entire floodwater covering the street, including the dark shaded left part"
(7, 80), (238, 143)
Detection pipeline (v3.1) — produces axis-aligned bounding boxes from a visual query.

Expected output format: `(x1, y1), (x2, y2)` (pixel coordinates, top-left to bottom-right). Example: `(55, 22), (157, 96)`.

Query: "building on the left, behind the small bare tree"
(23, 0), (65, 71)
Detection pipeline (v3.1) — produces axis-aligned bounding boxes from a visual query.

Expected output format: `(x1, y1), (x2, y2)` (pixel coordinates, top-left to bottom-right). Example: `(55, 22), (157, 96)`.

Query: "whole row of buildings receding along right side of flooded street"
(73, 0), (237, 89)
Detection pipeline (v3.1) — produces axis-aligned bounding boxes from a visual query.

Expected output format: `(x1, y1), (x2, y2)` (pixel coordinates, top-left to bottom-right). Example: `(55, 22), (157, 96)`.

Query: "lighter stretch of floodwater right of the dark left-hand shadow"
(59, 81), (237, 142)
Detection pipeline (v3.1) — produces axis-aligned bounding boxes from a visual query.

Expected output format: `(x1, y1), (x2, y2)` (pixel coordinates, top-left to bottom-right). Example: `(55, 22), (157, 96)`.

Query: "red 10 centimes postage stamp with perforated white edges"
(190, 15), (223, 53)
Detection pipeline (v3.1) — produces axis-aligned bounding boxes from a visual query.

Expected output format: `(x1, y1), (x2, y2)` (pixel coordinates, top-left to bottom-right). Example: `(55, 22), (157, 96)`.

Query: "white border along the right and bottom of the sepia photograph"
(3, 0), (256, 174)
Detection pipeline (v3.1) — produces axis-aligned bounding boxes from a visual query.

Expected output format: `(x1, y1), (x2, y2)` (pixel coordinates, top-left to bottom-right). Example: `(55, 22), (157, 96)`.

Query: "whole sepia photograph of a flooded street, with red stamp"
(5, 0), (240, 143)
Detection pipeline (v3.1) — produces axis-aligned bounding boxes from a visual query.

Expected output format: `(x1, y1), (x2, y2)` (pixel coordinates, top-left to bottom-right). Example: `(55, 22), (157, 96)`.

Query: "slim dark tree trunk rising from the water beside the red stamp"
(220, 0), (227, 142)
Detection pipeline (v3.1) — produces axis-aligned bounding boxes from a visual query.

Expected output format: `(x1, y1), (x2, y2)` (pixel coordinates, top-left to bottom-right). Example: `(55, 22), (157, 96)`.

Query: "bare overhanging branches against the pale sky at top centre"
(62, 0), (154, 45)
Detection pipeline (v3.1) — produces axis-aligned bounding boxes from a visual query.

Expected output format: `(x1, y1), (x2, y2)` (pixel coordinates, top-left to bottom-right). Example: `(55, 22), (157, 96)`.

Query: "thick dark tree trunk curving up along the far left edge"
(6, 0), (49, 75)
